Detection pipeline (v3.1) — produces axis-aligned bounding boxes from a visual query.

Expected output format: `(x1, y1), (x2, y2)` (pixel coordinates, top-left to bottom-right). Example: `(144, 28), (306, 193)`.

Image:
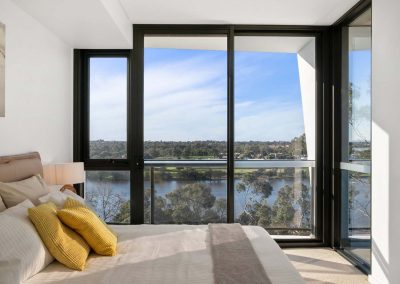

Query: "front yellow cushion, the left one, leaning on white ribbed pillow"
(28, 202), (90, 270)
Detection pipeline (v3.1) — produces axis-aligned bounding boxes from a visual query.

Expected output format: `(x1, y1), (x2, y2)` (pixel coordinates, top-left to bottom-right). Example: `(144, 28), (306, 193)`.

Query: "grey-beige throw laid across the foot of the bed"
(208, 224), (271, 284)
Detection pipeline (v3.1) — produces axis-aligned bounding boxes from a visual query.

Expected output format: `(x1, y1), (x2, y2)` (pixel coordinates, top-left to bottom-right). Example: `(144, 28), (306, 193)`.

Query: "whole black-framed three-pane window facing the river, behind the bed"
(74, 25), (330, 243)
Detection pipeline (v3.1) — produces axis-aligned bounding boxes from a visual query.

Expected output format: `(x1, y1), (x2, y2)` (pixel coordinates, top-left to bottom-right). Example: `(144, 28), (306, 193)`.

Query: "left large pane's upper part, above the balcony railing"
(144, 36), (227, 160)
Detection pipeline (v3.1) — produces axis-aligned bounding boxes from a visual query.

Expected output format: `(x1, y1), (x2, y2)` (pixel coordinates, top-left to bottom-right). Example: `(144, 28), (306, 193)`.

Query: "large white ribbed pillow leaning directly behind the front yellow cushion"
(0, 200), (54, 281)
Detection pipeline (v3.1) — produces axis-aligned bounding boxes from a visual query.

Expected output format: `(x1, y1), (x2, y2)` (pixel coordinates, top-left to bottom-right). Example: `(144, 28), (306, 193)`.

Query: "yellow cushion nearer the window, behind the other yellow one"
(57, 200), (117, 255)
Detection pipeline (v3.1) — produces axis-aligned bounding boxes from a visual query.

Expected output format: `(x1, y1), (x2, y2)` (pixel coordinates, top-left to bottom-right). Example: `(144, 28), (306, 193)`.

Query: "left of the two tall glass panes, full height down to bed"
(144, 35), (227, 224)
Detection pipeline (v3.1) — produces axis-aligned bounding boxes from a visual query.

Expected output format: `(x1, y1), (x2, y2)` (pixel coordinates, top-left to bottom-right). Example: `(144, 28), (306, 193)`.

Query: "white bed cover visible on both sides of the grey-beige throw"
(24, 225), (304, 284)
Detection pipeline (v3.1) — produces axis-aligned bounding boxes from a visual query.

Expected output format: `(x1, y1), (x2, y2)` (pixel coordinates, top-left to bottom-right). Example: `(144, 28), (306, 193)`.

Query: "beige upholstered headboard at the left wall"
(0, 152), (43, 182)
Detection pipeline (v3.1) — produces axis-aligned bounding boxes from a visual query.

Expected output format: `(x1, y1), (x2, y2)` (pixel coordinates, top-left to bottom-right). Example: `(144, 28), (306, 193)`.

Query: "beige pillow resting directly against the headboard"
(0, 175), (50, 207)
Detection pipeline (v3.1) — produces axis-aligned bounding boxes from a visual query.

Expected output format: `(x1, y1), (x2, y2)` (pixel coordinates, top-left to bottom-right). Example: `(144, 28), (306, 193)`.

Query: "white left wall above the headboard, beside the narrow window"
(0, 0), (73, 163)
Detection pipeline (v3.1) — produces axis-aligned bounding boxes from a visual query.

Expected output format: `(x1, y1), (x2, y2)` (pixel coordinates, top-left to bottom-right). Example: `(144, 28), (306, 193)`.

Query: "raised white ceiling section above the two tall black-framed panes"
(120, 0), (358, 25)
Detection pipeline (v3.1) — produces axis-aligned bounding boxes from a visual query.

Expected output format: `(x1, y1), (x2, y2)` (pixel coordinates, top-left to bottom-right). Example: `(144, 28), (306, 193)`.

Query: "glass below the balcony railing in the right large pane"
(235, 168), (314, 236)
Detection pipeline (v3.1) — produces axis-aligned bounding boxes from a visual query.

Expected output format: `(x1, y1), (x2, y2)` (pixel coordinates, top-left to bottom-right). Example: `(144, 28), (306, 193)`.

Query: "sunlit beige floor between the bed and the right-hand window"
(284, 248), (368, 284)
